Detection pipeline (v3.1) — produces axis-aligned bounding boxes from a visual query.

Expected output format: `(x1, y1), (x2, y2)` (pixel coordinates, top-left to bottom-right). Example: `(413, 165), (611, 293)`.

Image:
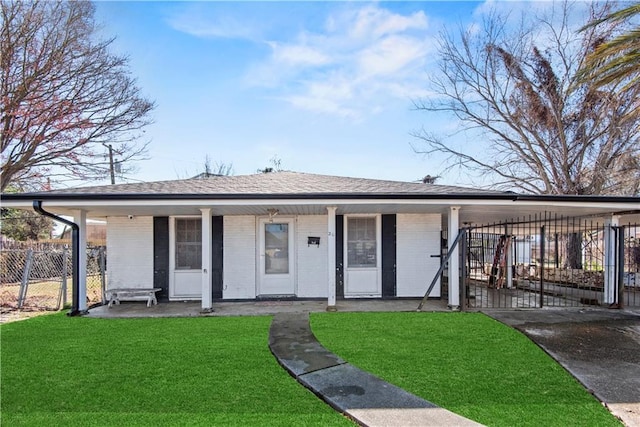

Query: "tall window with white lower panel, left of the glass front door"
(169, 217), (202, 300)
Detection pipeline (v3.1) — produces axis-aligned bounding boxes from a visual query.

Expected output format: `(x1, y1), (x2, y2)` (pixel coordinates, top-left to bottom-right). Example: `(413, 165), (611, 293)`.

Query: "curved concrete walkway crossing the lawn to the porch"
(269, 313), (481, 427)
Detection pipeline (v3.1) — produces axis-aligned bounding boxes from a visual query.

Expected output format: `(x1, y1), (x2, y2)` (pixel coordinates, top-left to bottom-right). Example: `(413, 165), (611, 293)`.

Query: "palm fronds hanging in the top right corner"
(579, 3), (640, 89)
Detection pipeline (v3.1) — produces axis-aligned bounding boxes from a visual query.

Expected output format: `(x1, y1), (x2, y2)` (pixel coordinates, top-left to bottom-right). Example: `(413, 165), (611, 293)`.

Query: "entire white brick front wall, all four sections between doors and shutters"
(107, 214), (441, 299)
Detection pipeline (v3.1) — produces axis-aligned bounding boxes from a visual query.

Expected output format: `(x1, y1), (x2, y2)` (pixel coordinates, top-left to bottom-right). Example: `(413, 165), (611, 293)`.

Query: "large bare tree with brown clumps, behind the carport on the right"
(414, 2), (640, 194)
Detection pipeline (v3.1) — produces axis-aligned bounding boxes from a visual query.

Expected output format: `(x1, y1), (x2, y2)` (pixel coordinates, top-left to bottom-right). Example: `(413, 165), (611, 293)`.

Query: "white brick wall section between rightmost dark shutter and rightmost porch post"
(396, 214), (441, 297)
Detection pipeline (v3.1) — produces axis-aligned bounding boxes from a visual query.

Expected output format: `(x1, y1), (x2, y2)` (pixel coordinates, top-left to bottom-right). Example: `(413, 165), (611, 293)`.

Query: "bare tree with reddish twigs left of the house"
(0, 0), (154, 190)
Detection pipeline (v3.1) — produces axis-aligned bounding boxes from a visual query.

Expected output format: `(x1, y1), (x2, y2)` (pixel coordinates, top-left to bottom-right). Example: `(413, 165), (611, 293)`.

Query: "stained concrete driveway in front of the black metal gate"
(484, 308), (640, 427)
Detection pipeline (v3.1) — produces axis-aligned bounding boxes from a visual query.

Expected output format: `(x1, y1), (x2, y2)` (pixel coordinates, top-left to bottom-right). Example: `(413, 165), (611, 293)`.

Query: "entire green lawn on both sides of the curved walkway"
(0, 313), (620, 426)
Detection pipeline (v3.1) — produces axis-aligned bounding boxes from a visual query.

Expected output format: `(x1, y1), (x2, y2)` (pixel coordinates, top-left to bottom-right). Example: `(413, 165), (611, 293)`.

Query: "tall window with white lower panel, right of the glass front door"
(344, 215), (382, 298)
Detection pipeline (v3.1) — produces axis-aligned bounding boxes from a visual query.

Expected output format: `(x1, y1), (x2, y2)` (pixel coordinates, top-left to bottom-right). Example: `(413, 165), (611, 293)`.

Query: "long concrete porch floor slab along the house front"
(89, 298), (449, 318)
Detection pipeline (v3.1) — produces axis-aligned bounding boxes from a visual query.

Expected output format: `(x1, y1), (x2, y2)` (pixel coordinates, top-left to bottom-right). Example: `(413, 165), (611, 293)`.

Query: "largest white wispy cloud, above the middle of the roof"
(246, 4), (434, 118)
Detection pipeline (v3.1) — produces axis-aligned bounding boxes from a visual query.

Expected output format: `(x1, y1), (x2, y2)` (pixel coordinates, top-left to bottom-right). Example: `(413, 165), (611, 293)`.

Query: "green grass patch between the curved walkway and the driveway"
(311, 313), (621, 426)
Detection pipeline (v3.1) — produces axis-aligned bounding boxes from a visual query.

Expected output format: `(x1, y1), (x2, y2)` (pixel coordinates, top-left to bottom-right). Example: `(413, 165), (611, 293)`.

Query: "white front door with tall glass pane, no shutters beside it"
(258, 218), (296, 296)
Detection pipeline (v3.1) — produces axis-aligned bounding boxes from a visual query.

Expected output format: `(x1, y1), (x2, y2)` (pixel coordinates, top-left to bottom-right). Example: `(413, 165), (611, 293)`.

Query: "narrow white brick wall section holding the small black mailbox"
(296, 215), (328, 298)
